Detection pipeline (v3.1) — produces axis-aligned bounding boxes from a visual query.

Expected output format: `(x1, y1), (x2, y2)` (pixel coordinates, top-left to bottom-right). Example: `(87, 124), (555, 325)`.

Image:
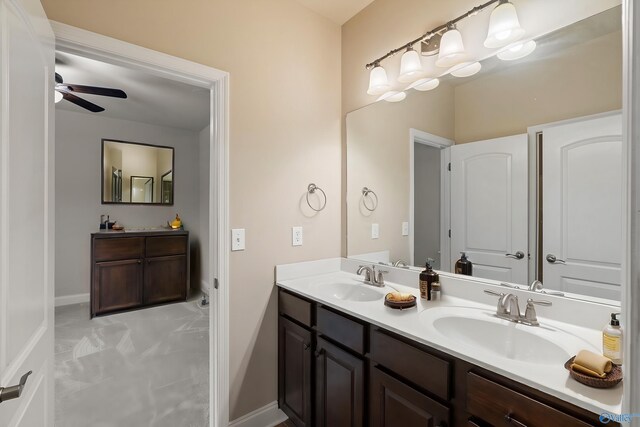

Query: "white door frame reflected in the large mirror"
(407, 128), (455, 271)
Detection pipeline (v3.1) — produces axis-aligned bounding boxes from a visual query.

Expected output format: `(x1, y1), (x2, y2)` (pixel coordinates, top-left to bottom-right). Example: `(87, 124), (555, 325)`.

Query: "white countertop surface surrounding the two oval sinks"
(276, 261), (622, 414)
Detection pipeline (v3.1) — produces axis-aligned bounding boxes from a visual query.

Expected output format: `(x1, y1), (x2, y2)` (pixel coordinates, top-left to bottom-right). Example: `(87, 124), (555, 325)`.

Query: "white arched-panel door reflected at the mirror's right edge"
(542, 114), (625, 300)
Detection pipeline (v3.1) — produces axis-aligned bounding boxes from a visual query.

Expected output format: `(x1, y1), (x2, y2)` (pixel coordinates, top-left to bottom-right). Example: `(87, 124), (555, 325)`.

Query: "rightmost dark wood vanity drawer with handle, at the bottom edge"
(467, 372), (591, 427)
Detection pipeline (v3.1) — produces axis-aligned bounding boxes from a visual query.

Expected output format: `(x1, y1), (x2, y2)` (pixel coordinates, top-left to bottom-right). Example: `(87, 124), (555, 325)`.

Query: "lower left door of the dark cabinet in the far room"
(91, 259), (143, 316)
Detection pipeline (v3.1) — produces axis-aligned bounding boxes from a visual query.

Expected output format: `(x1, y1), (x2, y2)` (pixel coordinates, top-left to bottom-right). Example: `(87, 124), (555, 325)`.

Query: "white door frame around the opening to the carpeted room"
(50, 21), (229, 427)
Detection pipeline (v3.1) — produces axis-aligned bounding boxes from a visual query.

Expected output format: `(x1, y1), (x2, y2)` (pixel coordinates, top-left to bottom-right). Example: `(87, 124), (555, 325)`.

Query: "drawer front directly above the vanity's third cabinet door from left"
(370, 329), (451, 400)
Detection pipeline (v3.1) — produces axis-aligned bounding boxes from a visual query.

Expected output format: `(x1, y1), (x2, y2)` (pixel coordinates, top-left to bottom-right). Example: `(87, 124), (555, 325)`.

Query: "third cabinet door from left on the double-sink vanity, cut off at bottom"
(369, 367), (449, 427)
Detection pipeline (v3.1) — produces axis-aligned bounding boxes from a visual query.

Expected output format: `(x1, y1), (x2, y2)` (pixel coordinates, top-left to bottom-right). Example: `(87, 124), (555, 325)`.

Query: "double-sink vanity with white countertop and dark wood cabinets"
(276, 259), (622, 427)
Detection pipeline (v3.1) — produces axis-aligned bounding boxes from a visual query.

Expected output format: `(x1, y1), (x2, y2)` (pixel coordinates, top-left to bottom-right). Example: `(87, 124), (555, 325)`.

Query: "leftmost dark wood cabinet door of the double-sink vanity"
(278, 316), (312, 427)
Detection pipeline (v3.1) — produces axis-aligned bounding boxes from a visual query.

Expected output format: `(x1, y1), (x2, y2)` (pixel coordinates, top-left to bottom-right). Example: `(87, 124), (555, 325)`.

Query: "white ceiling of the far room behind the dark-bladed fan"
(56, 52), (209, 131)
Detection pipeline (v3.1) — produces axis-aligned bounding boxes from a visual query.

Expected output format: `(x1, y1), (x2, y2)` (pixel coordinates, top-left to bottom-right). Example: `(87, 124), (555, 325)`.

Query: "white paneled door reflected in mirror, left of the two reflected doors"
(451, 135), (529, 284)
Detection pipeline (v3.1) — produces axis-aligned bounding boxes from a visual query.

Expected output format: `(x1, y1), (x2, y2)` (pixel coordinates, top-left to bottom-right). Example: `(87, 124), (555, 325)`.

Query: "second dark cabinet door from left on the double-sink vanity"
(315, 338), (364, 427)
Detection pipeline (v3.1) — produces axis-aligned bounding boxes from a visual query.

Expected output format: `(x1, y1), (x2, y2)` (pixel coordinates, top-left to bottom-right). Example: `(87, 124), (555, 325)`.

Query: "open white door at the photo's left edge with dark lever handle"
(0, 0), (54, 427)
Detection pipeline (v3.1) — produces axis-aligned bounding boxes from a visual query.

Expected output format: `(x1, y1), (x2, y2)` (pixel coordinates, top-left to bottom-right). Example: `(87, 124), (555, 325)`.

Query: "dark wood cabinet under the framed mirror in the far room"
(91, 230), (189, 317)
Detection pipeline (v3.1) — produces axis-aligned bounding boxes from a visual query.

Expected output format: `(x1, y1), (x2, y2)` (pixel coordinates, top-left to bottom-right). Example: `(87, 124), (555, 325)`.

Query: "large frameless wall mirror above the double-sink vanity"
(347, 4), (626, 301)
